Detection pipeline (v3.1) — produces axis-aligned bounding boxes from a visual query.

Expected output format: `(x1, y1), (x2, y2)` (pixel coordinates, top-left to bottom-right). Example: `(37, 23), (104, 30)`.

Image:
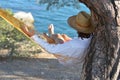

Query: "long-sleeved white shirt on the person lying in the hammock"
(31, 35), (91, 65)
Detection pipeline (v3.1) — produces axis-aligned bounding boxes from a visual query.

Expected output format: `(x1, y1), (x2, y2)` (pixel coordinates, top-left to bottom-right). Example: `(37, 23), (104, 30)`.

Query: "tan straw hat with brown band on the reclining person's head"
(68, 11), (95, 33)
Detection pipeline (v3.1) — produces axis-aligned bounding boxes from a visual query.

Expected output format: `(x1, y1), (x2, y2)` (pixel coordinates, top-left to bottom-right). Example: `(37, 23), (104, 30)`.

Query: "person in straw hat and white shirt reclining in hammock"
(22, 11), (95, 65)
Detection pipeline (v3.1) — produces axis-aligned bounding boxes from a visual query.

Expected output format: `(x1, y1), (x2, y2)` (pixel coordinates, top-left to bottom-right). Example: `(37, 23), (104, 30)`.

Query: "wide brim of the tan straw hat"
(68, 15), (95, 33)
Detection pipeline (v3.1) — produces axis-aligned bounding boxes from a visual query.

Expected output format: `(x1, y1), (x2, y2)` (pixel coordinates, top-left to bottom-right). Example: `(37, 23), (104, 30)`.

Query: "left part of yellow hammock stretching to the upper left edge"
(0, 8), (47, 52)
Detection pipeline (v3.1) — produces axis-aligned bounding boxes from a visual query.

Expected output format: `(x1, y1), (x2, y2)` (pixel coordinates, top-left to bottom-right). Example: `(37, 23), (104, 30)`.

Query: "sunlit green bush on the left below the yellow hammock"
(0, 10), (41, 57)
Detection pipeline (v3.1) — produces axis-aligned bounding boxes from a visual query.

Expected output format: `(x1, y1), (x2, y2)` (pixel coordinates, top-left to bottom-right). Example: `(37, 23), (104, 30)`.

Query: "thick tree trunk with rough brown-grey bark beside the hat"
(79, 0), (120, 80)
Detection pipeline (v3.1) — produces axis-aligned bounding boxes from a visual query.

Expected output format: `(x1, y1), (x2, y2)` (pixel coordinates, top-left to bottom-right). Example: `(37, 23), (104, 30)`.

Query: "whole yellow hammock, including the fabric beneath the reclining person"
(0, 8), (77, 62)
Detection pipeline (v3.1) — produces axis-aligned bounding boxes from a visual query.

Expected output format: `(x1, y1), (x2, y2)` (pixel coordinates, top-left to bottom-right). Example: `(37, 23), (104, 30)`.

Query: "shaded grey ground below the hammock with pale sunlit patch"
(0, 53), (82, 80)
